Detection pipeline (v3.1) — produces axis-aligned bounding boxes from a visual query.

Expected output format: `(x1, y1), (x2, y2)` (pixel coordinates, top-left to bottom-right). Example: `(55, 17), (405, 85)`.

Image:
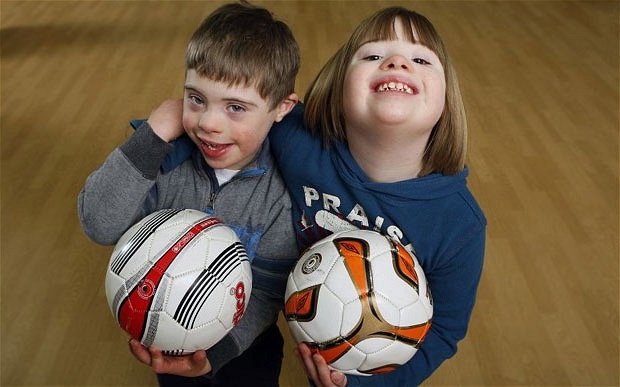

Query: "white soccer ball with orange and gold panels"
(284, 230), (433, 375)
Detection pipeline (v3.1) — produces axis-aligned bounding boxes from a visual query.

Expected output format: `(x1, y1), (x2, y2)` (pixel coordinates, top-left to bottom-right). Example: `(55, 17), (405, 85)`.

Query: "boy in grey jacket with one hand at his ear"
(78, 3), (299, 386)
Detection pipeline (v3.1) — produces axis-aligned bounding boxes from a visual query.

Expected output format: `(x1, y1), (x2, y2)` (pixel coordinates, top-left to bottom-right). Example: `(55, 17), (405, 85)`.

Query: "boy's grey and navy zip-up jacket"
(78, 121), (298, 373)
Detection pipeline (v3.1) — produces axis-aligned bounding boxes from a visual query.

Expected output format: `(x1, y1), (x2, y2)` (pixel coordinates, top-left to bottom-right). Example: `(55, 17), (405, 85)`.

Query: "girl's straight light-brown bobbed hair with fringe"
(304, 7), (467, 176)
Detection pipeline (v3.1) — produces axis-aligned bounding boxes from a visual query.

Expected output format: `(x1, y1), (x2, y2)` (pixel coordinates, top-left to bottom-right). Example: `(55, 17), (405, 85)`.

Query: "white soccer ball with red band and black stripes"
(105, 209), (252, 355)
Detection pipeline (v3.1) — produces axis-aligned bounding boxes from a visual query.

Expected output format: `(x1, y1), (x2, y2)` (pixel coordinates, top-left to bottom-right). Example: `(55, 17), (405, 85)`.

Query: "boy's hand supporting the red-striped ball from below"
(129, 338), (211, 377)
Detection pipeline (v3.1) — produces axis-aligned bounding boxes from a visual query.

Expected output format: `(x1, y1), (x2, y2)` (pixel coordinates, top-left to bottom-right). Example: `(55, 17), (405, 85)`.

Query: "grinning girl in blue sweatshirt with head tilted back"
(270, 7), (486, 387)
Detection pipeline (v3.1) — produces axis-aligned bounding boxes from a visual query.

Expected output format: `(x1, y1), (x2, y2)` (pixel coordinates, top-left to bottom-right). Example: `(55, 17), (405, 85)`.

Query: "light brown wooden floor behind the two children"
(0, 0), (620, 386)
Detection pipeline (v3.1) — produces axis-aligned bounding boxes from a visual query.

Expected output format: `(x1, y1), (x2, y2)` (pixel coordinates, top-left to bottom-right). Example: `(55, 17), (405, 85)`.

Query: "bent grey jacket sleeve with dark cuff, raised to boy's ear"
(78, 121), (172, 245)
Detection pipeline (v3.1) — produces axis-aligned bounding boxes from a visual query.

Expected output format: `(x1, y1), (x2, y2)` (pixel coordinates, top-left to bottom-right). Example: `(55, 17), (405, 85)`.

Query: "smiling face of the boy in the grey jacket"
(183, 70), (295, 170)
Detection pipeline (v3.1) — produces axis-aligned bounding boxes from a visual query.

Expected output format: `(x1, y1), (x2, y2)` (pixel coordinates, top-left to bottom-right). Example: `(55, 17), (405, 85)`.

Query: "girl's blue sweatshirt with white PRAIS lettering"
(269, 106), (486, 387)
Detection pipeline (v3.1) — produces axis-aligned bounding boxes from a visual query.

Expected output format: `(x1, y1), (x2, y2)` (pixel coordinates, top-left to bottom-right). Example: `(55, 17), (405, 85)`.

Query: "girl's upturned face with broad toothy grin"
(343, 20), (446, 142)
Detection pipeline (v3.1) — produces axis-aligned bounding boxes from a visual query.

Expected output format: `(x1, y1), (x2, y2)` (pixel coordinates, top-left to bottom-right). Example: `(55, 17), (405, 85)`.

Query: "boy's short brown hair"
(185, 1), (300, 109)
